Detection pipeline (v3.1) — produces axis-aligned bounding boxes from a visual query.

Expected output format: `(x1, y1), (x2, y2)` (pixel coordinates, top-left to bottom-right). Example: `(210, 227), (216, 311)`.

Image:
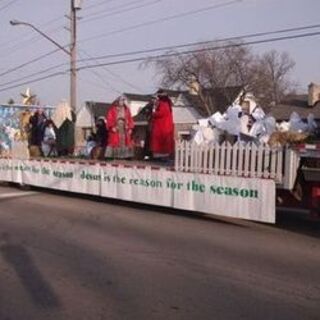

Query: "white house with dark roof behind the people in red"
(77, 86), (256, 143)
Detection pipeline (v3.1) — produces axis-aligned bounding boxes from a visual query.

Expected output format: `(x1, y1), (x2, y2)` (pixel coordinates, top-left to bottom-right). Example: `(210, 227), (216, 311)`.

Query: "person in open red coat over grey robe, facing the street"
(105, 96), (134, 159)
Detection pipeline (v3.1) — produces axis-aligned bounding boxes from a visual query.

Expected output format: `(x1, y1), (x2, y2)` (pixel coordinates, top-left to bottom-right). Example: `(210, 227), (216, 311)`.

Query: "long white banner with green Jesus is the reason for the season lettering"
(0, 159), (275, 223)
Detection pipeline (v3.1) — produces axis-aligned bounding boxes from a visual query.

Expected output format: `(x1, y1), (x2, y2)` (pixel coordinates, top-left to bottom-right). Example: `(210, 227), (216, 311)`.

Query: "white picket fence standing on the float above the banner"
(175, 141), (285, 183)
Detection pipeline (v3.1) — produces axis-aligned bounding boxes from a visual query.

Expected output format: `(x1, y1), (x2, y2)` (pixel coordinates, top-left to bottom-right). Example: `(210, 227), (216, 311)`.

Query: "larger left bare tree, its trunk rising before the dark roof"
(156, 42), (253, 115)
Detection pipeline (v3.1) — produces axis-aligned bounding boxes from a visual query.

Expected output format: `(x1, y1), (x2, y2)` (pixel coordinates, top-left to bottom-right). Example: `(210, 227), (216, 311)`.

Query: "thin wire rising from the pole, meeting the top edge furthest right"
(79, 0), (244, 42)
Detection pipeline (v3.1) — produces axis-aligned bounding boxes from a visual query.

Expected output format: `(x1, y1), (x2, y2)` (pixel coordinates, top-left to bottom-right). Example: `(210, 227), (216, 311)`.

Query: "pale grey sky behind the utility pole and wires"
(0, 0), (320, 104)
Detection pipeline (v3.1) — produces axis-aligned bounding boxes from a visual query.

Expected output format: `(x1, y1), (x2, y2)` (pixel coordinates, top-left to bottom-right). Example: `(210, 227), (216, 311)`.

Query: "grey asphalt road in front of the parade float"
(0, 186), (320, 320)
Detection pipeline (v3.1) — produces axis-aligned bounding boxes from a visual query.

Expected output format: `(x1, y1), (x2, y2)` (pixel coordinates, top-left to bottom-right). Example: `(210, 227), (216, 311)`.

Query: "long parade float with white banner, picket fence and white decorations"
(0, 89), (320, 223)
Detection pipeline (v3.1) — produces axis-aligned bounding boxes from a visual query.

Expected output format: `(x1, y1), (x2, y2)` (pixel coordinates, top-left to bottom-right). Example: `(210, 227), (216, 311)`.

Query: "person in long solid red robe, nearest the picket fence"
(150, 90), (174, 159)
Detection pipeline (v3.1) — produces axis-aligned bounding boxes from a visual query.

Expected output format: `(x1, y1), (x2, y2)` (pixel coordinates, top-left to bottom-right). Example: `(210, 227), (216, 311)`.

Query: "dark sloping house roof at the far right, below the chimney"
(267, 94), (320, 121)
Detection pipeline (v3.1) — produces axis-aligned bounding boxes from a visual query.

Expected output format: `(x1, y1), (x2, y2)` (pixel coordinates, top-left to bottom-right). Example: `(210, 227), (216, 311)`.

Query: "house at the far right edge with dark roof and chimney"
(268, 83), (320, 125)
